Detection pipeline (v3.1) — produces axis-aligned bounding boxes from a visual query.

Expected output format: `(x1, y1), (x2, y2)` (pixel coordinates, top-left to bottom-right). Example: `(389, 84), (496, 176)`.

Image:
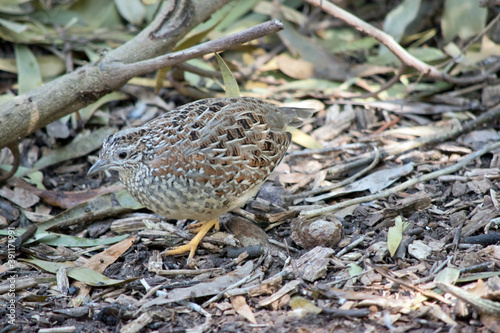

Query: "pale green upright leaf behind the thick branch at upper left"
(14, 44), (42, 95)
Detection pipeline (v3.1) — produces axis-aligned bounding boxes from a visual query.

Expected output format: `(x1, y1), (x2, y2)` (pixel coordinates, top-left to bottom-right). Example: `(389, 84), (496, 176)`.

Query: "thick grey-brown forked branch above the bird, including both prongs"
(0, 0), (283, 153)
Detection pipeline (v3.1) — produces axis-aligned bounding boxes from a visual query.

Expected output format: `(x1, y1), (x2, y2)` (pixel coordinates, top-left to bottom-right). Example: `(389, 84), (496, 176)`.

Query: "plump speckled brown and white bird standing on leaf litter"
(89, 98), (309, 257)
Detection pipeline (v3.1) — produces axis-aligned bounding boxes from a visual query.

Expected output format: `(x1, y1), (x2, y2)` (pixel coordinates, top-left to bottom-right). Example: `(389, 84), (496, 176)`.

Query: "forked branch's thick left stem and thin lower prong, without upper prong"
(0, 20), (283, 156)
